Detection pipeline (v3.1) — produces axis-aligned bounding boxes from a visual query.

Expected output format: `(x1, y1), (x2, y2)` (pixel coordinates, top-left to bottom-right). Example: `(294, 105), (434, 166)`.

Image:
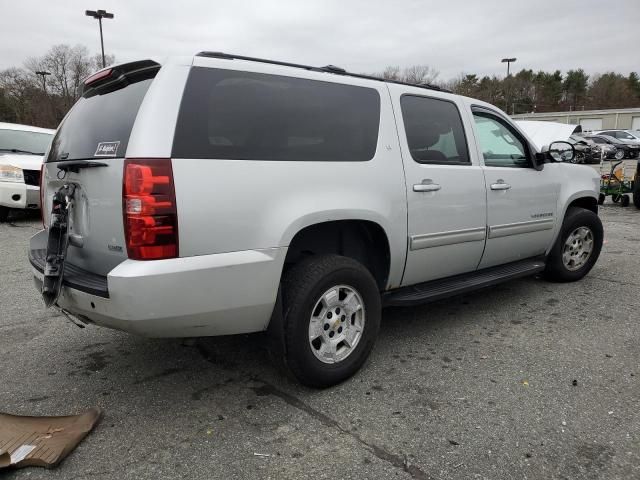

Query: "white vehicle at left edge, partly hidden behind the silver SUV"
(0, 123), (55, 222)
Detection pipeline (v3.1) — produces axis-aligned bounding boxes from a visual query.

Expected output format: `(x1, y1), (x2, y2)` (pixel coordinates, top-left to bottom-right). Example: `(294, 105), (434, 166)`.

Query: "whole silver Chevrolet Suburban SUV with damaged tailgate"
(29, 52), (603, 387)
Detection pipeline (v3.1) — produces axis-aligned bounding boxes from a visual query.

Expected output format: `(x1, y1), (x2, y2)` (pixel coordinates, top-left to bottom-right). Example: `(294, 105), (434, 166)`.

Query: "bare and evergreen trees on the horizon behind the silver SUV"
(0, 45), (640, 128)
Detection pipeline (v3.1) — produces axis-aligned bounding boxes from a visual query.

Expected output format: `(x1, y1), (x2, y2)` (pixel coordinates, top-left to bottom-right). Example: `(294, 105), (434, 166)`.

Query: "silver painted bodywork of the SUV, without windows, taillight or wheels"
(31, 57), (599, 337)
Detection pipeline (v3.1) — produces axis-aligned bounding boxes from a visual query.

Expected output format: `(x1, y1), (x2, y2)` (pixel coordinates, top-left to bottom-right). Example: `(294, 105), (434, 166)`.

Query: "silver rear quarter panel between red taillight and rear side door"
(173, 64), (407, 288)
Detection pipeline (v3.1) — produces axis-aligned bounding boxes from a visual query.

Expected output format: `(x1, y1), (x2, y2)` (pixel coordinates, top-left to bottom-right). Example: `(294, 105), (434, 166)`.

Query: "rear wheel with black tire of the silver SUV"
(283, 255), (381, 388)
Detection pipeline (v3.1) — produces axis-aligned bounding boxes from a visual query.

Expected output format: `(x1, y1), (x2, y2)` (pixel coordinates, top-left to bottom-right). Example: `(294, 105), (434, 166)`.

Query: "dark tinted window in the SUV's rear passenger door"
(400, 95), (469, 164)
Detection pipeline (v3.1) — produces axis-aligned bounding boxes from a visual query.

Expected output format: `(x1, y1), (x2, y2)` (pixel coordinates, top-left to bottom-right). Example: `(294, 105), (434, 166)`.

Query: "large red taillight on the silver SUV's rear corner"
(122, 158), (178, 260)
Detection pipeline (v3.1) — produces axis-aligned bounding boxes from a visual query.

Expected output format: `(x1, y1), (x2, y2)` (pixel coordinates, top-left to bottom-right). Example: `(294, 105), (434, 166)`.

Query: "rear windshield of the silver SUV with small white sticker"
(47, 78), (153, 162)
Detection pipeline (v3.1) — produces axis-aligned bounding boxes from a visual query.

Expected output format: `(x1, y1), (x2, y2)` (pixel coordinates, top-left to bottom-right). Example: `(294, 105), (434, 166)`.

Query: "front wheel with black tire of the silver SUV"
(544, 207), (604, 282)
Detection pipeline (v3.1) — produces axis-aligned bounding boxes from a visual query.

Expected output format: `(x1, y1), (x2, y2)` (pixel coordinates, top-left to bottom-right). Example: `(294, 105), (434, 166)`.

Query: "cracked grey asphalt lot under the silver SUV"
(0, 204), (640, 480)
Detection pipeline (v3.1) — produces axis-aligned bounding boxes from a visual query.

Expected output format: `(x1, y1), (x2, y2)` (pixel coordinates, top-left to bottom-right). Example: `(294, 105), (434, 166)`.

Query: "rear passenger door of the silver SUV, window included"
(390, 85), (486, 286)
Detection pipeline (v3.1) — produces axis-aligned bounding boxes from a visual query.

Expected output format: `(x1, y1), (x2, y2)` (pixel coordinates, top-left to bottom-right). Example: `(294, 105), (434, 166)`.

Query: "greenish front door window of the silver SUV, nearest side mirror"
(473, 112), (531, 167)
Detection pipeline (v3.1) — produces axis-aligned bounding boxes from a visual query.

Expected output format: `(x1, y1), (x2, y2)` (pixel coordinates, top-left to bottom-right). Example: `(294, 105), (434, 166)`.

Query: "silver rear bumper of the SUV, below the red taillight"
(29, 230), (286, 337)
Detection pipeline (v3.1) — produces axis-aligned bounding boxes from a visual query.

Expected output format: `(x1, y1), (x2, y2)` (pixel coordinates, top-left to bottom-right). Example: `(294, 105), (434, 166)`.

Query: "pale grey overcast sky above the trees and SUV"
(0, 0), (640, 80)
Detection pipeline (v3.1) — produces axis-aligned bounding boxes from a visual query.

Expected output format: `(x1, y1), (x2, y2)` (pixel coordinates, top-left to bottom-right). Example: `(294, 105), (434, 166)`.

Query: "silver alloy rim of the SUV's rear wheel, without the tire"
(309, 285), (366, 363)
